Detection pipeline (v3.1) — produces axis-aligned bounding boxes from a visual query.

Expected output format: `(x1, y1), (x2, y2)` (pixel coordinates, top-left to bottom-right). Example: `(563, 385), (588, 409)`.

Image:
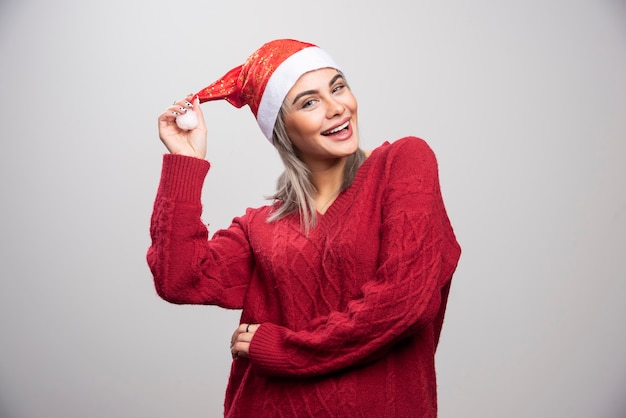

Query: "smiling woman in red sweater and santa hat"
(148, 39), (460, 418)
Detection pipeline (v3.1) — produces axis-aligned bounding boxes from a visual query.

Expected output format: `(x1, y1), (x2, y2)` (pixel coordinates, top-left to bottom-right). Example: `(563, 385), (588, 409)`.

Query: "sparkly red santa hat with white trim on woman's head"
(178, 39), (339, 142)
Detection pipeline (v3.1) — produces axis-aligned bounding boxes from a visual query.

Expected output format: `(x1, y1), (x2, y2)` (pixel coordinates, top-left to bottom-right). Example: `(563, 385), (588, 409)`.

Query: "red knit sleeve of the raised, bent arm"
(147, 154), (253, 309)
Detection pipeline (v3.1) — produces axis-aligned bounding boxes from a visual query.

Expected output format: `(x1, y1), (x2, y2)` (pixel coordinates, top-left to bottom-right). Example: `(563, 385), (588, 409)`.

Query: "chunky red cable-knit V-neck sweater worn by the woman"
(148, 137), (460, 418)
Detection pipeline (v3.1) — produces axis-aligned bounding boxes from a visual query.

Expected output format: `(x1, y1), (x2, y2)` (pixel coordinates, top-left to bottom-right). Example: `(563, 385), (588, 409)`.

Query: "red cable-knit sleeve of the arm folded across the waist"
(250, 138), (460, 376)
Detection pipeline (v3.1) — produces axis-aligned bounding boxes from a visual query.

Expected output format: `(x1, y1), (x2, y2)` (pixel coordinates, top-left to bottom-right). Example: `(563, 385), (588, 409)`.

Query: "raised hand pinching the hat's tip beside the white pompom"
(159, 94), (207, 159)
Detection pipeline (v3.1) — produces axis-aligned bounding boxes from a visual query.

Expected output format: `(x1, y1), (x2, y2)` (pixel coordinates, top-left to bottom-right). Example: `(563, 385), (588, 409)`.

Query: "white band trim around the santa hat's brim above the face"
(257, 46), (339, 143)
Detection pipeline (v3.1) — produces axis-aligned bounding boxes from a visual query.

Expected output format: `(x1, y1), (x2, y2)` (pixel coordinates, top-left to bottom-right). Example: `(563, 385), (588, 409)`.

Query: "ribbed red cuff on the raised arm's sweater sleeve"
(158, 154), (211, 202)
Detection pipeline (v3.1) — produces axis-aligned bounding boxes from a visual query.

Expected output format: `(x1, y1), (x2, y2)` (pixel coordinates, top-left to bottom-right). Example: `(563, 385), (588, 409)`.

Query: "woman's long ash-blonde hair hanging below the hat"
(267, 102), (366, 234)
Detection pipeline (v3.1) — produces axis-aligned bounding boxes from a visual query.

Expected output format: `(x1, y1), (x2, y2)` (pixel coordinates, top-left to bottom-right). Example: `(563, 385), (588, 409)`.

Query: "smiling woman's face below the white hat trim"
(284, 68), (359, 166)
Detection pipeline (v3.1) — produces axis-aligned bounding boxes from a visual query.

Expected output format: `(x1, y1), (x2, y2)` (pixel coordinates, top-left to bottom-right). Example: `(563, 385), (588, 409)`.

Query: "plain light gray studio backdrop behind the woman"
(0, 0), (626, 418)
